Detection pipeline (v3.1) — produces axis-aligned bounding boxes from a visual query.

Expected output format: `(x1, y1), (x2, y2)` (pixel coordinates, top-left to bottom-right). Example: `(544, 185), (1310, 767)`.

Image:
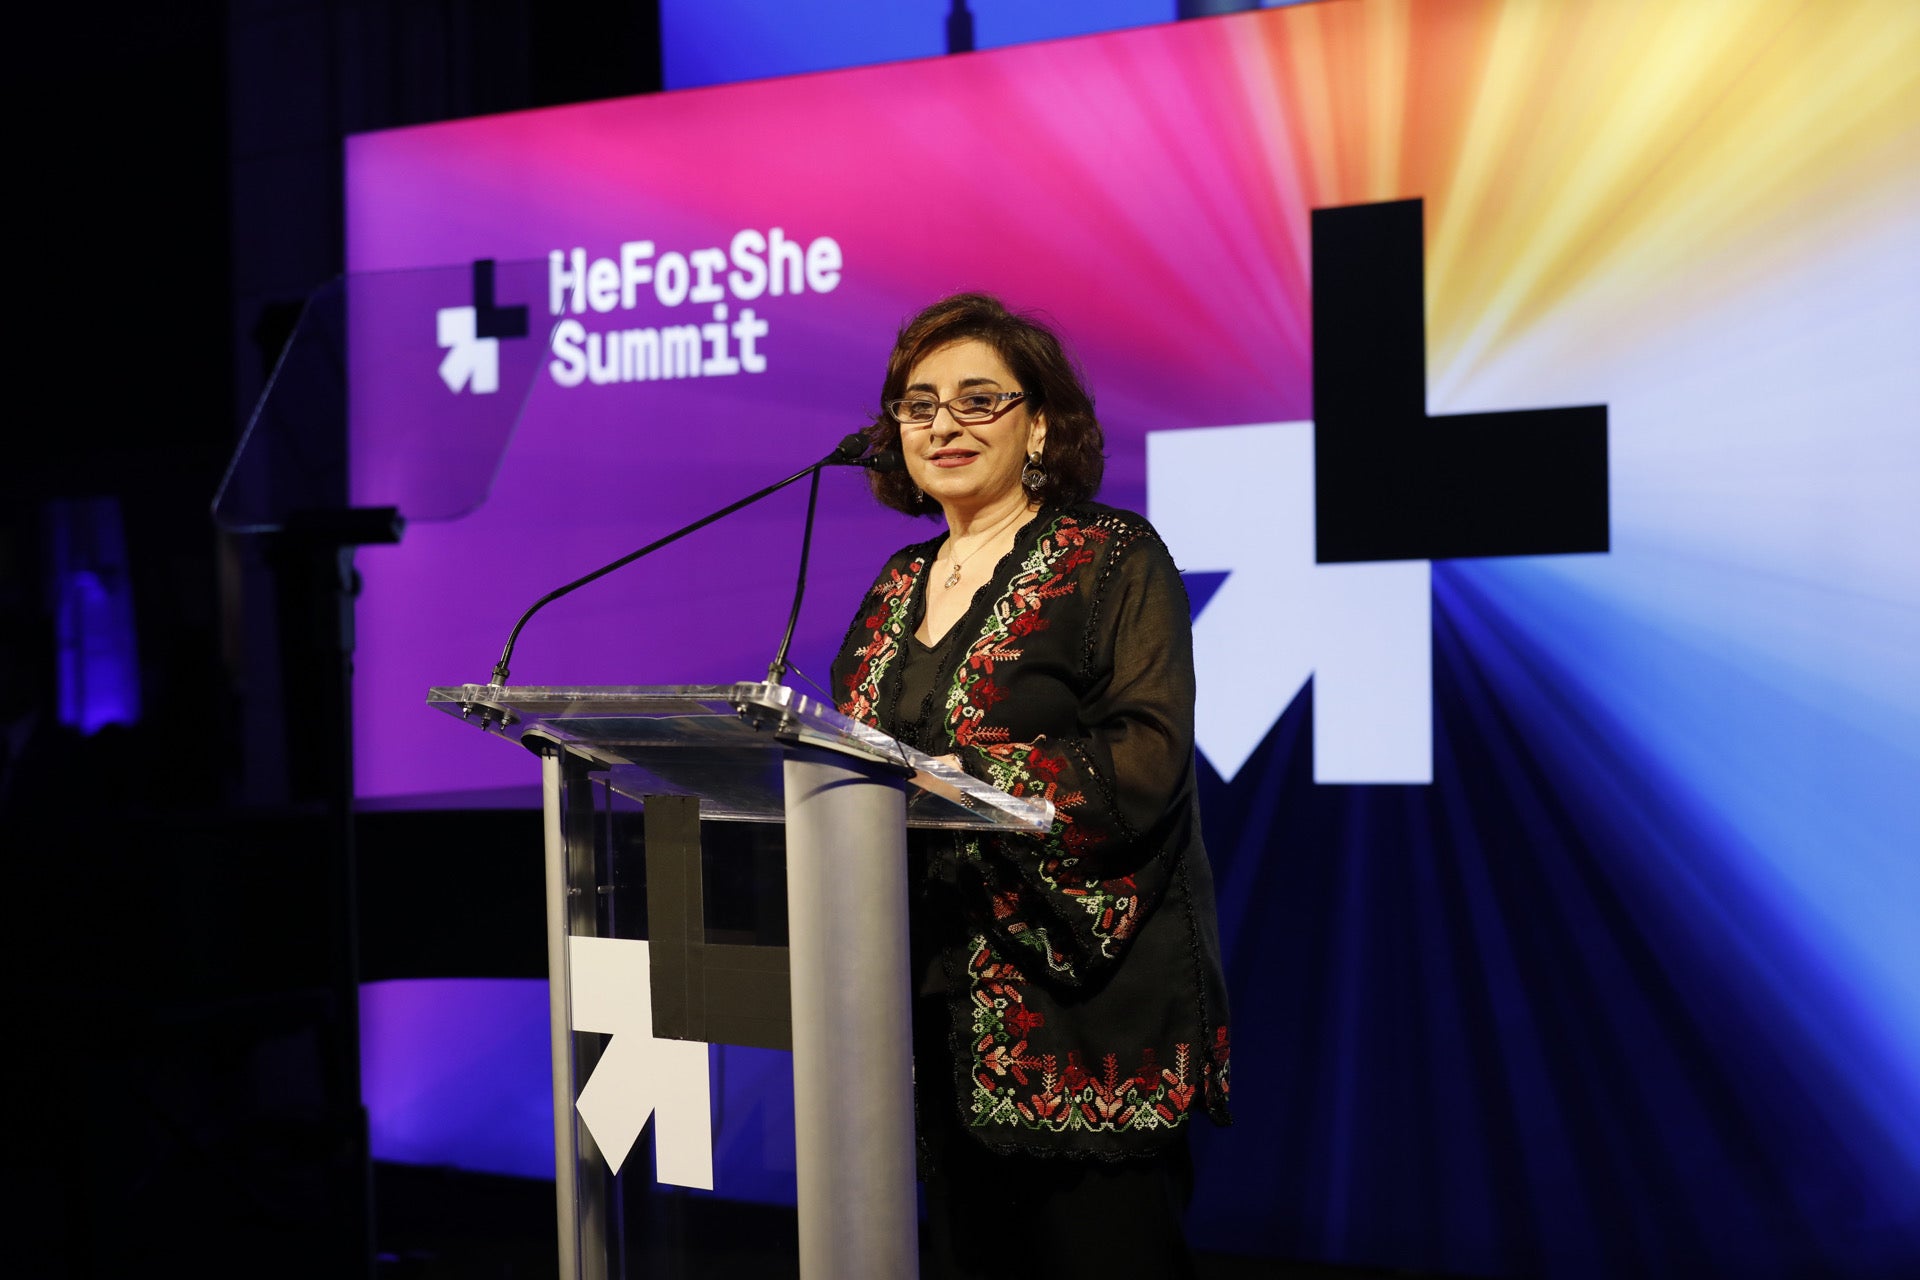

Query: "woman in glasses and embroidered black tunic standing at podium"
(833, 294), (1229, 1278)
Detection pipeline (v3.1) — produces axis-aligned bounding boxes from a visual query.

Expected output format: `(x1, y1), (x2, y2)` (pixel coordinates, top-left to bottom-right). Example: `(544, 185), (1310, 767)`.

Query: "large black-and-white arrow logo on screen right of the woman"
(1146, 200), (1609, 783)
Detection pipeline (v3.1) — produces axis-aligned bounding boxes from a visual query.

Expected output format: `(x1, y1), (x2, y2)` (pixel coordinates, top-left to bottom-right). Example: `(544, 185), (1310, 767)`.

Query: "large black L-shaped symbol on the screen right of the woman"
(1313, 200), (1607, 564)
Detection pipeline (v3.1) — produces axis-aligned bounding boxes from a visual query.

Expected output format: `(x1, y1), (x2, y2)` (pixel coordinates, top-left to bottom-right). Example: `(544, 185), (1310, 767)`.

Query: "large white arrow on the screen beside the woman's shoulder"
(1146, 422), (1434, 783)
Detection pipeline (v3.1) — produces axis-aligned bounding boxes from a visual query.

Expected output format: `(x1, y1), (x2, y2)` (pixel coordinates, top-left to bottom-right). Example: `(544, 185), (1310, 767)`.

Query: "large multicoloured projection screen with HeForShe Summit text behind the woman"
(348, 0), (1920, 1274)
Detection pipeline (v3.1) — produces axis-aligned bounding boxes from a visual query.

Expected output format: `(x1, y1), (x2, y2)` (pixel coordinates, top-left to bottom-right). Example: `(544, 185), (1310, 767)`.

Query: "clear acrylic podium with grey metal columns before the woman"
(428, 683), (1052, 1280)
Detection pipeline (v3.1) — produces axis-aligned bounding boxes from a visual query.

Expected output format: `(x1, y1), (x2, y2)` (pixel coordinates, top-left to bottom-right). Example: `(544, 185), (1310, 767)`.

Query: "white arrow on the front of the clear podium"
(566, 938), (714, 1192)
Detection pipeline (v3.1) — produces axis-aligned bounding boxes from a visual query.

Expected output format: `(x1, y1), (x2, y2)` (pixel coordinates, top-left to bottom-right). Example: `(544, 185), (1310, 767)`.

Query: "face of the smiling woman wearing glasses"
(900, 338), (1046, 518)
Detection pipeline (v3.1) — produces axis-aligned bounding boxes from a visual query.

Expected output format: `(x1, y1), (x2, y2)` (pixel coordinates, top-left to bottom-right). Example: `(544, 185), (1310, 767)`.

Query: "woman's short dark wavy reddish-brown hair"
(866, 294), (1106, 516)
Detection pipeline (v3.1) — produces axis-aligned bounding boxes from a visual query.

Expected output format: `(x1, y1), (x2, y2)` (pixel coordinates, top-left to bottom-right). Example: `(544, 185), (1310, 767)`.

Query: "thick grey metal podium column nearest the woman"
(785, 747), (920, 1280)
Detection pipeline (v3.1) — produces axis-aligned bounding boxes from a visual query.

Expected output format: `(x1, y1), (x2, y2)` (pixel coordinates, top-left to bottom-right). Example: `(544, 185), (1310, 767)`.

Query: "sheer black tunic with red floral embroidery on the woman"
(833, 503), (1229, 1159)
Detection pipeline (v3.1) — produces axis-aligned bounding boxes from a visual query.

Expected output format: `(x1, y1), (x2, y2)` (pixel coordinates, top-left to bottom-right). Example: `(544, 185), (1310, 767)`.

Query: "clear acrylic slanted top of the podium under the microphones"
(426, 683), (1054, 833)
